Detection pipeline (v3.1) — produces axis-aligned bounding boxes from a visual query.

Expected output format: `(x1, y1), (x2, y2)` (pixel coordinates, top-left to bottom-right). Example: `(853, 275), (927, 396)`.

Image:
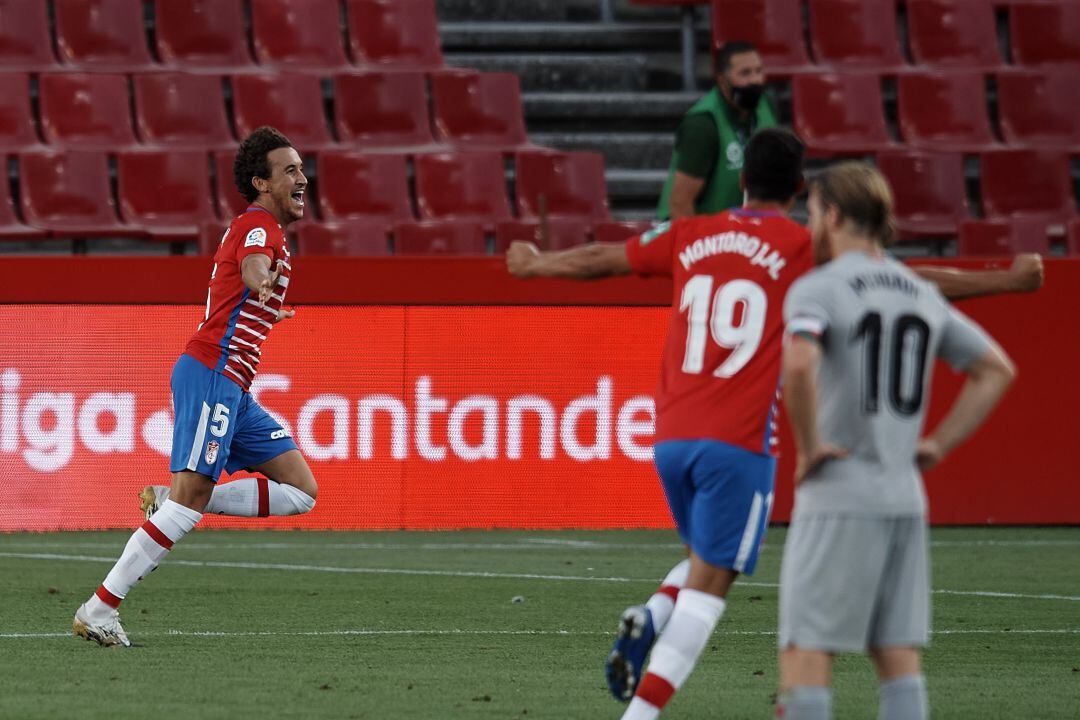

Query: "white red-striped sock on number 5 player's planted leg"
(86, 500), (202, 617)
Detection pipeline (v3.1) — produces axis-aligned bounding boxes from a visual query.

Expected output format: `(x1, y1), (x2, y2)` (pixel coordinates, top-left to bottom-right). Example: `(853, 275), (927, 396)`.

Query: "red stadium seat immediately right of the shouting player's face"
(319, 150), (413, 229)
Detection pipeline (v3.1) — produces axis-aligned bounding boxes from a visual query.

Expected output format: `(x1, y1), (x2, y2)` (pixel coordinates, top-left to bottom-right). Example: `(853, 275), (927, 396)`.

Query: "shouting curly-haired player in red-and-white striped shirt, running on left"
(72, 127), (318, 647)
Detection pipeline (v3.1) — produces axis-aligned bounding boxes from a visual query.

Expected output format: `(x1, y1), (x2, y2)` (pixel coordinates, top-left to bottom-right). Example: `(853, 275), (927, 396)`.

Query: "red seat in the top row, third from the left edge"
(154, 0), (254, 73)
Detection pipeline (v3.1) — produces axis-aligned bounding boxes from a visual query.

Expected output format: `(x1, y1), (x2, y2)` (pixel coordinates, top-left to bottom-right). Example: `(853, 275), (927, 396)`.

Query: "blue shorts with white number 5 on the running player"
(168, 355), (296, 483)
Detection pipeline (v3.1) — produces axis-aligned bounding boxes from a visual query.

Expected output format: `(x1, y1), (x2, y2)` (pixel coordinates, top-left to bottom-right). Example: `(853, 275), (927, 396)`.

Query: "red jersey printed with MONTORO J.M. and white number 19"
(626, 209), (813, 456)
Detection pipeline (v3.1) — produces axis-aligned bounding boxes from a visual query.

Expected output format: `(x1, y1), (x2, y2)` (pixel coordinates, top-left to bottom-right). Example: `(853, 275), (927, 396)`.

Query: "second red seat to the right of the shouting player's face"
(415, 152), (511, 230)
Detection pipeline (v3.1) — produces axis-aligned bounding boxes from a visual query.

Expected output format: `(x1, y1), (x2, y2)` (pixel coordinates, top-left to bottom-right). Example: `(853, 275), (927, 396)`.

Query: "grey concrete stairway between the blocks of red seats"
(436, 0), (711, 219)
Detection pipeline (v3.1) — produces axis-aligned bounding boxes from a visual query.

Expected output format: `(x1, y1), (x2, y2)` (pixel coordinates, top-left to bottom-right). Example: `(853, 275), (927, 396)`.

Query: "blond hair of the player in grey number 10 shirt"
(811, 161), (896, 247)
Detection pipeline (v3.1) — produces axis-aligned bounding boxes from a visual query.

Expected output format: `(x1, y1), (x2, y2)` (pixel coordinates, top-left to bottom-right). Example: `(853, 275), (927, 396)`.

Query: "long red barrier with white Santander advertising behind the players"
(0, 258), (1080, 530)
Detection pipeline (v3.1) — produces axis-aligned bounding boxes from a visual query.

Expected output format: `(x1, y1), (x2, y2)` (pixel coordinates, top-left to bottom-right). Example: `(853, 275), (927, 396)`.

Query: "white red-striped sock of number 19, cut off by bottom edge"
(622, 588), (726, 720)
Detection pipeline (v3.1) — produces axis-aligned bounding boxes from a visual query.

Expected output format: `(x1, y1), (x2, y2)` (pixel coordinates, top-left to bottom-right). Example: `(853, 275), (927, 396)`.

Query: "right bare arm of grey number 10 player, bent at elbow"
(916, 344), (1016, 470)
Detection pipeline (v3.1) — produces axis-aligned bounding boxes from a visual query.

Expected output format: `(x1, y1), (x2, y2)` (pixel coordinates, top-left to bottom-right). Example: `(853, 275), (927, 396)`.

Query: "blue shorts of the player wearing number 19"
(653, 440), (777, 575)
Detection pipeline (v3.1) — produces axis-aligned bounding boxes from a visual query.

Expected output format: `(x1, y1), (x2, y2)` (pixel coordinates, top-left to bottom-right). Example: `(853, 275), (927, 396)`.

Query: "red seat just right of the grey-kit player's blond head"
(876, 150), (969, 237)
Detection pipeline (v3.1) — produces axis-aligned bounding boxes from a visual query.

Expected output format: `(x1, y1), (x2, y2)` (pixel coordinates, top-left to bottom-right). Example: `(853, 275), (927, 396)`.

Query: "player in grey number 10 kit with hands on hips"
(778, 163), (1015, 720)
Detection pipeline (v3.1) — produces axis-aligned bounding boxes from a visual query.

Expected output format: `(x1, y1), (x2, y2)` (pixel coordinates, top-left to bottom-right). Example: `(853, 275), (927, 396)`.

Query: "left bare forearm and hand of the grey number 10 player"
(781, 335), (847, 485)
